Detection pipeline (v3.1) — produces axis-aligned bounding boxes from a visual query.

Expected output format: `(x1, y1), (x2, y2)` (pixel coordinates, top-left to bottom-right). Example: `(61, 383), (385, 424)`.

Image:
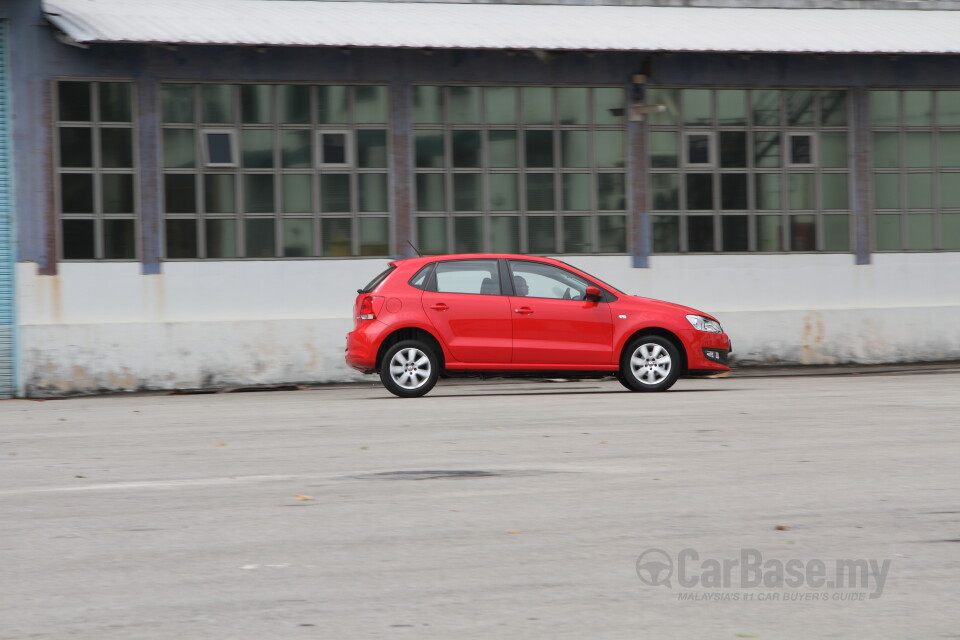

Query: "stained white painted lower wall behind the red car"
(17, 253), (960, 396)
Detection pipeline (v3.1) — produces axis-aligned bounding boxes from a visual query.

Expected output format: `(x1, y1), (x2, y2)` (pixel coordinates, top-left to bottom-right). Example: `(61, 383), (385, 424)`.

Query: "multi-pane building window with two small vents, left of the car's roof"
(161, 83), (390, 260)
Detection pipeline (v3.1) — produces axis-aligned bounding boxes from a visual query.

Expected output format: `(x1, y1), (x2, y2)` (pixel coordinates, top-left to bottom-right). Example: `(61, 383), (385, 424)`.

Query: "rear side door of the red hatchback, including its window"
(421, 259), (513, 364)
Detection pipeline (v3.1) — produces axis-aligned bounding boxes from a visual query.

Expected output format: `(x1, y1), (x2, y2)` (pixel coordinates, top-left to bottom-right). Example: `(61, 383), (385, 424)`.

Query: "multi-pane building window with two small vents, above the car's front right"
(647, 87), (851, 253)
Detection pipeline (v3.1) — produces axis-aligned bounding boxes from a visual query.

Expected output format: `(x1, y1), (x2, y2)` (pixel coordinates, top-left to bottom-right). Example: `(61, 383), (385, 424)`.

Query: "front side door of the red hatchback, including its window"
(509, 260), (614, 365)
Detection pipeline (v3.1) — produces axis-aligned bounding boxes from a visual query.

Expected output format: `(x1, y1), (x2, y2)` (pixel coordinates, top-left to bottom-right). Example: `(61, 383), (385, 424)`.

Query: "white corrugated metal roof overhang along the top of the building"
(43, 0), (960, 54)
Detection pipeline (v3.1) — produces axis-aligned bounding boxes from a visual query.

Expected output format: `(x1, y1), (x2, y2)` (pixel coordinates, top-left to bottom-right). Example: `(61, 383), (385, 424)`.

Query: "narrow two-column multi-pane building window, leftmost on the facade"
(56, 80), (137, 260)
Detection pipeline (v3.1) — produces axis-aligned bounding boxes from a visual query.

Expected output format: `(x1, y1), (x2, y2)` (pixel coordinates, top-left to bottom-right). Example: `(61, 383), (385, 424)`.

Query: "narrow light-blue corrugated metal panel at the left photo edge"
(0, 20), (17, 398)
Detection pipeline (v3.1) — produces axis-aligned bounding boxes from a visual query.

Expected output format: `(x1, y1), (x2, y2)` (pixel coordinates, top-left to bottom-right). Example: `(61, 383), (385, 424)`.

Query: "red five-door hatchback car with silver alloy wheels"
(346, 254), (730, 398)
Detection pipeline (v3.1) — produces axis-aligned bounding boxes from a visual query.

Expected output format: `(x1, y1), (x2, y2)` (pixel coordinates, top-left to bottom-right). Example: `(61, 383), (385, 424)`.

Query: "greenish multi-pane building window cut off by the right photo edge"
(870, 90), (960, 251)
